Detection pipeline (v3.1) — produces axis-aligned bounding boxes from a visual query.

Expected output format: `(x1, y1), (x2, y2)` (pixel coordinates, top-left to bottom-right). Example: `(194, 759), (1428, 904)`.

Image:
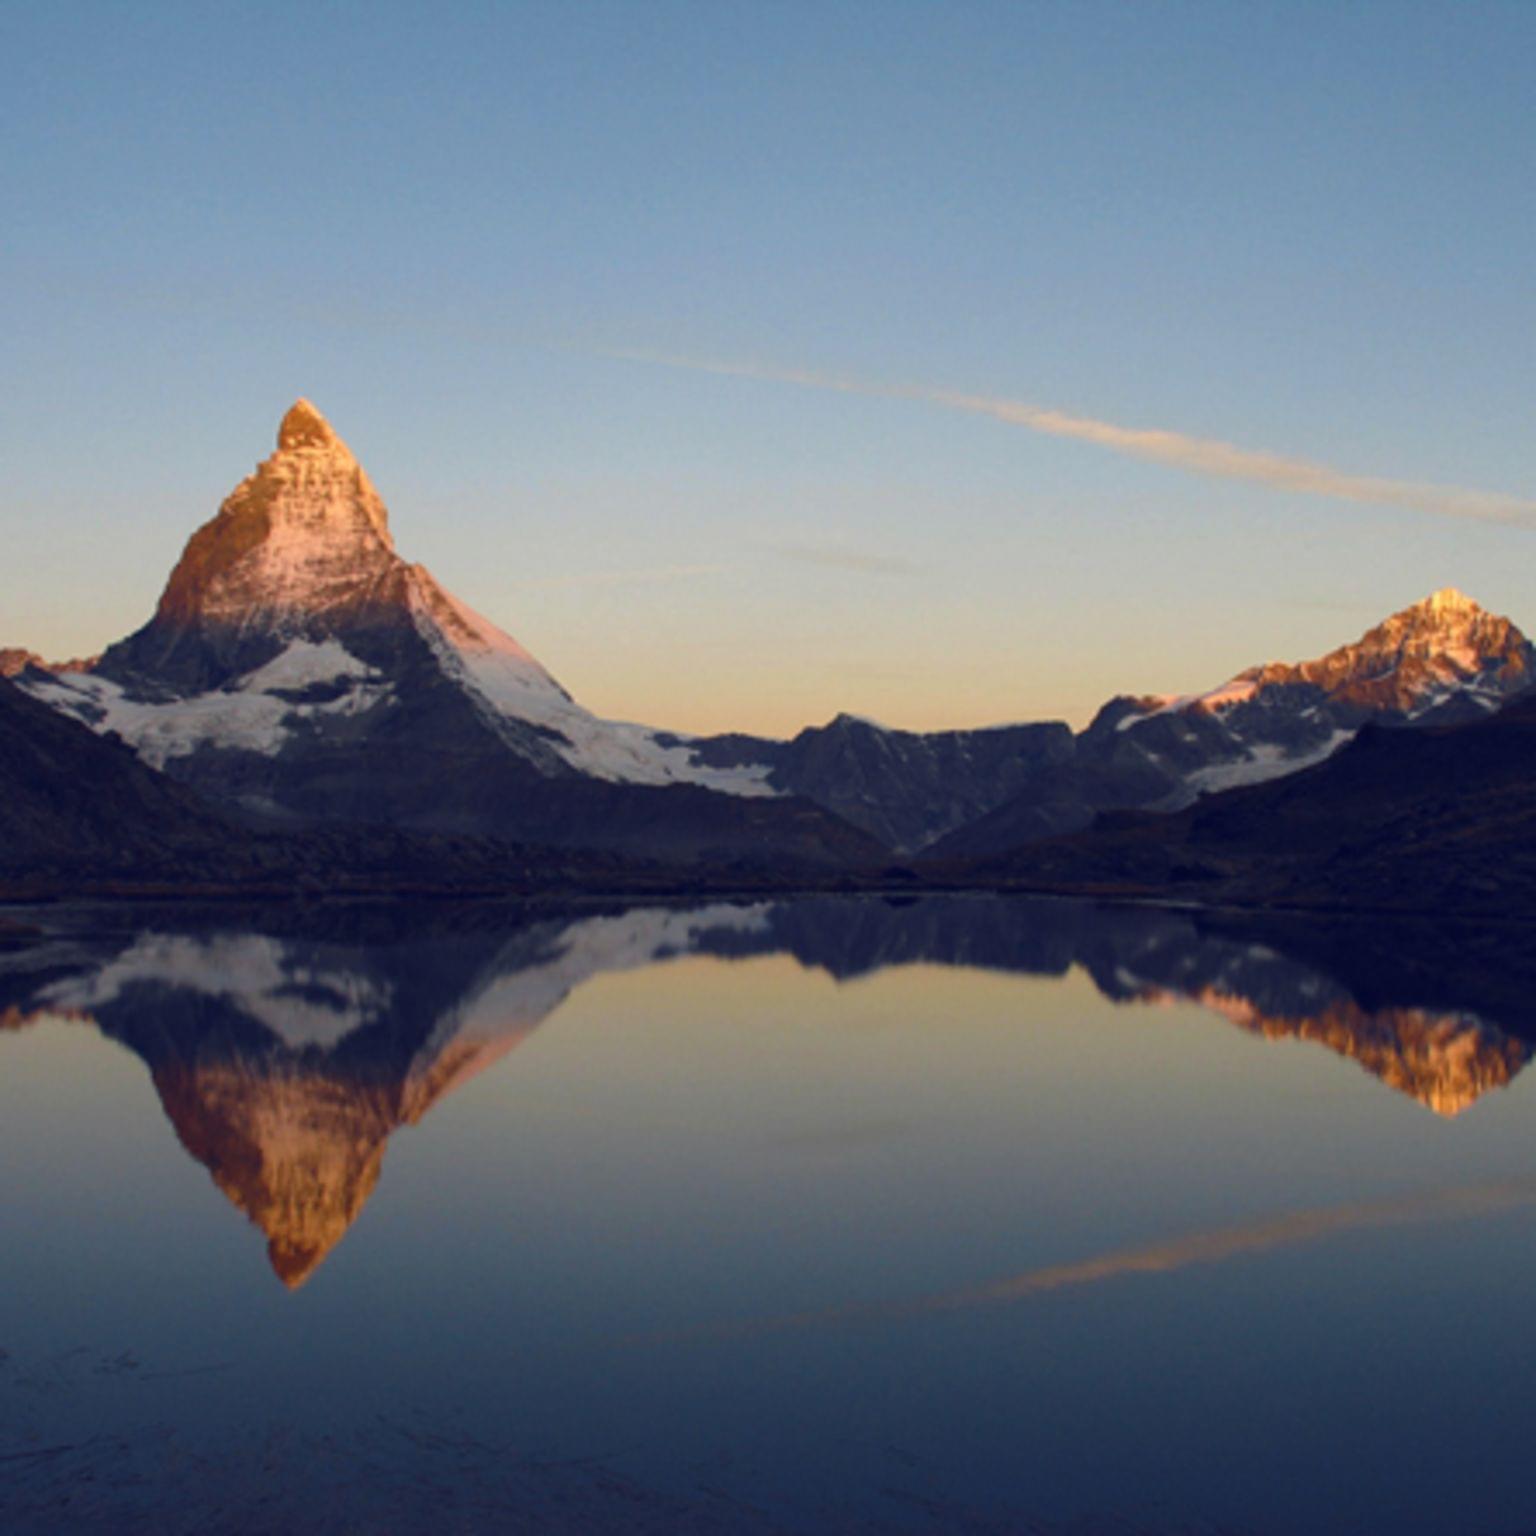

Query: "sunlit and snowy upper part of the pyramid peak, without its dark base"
(36, 399), (776, 796)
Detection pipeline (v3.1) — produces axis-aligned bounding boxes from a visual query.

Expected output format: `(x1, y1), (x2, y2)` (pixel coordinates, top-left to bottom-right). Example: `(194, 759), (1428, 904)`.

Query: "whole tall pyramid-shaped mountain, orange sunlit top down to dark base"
(22, 401), (880, 865)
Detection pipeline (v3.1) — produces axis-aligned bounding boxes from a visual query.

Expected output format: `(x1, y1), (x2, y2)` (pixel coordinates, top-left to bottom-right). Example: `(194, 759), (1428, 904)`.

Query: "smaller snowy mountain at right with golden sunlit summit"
(929, 590), (1536, 859)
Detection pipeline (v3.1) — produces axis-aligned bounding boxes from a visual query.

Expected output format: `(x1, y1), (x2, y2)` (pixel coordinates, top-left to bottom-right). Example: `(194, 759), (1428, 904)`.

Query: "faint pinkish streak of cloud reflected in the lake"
(637, 1180), (1536, 1342)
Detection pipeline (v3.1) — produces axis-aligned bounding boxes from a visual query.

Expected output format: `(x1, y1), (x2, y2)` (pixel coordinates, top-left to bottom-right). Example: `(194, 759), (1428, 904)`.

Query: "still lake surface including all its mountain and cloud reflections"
(0, 899), (1536, 1533)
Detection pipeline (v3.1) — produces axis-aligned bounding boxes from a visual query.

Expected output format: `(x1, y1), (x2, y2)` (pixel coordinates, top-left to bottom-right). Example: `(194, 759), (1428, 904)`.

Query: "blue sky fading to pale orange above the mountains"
(0, 0), (1536, 733)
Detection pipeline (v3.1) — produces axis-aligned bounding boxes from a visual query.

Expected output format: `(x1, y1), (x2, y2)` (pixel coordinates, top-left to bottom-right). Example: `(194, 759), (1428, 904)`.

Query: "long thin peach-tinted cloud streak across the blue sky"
(605, 350), (1536, 527)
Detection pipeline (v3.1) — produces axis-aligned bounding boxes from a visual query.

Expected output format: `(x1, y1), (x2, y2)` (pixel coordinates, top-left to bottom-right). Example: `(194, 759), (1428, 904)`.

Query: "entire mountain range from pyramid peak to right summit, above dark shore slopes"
(0, 401), (1533, 897)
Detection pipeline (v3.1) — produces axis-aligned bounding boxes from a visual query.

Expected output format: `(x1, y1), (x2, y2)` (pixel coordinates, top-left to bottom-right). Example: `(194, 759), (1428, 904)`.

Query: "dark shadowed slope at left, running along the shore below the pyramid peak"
(0, 679), (879, 897)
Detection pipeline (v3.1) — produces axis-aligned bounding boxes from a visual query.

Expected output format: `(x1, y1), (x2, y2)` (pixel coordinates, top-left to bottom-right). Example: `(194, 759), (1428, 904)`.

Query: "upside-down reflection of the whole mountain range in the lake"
(0, 897), (1536, 1286)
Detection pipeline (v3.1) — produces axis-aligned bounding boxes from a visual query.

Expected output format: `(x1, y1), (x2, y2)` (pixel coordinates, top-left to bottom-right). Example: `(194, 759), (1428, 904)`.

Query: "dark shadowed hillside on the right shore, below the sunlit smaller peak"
(931, 696), (1536, 919)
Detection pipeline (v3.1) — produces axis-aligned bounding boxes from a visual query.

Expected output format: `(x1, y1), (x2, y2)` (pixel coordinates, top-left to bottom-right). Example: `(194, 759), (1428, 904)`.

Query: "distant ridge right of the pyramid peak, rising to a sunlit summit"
(693, 590), (1533, 857)
